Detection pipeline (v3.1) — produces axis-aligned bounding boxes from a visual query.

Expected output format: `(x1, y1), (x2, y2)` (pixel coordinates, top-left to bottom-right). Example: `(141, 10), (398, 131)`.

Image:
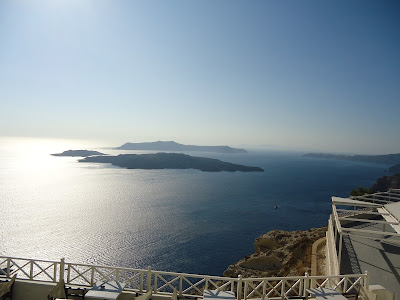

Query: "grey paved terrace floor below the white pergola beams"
(341, 225), (400, 300)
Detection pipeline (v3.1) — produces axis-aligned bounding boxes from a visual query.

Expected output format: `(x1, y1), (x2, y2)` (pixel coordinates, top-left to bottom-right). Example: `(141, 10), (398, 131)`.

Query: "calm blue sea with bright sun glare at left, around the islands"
(0, 138), (387, 275)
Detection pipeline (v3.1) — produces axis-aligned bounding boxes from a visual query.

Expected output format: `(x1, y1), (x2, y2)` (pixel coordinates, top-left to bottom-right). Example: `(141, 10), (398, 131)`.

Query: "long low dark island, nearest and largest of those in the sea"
(79, 153), (264, 172)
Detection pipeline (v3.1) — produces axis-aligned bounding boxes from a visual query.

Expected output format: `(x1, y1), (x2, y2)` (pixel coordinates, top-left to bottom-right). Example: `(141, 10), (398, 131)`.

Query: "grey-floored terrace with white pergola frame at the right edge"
(328, 189), (400, 300)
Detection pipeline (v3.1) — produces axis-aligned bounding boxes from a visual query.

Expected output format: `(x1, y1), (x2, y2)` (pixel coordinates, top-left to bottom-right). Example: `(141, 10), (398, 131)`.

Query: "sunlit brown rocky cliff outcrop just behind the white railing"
(224, 227), (327, 277)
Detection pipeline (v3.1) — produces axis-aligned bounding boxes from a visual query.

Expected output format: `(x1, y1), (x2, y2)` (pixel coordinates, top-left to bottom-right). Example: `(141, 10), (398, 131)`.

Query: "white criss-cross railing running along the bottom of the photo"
(0, 256), (369, 300)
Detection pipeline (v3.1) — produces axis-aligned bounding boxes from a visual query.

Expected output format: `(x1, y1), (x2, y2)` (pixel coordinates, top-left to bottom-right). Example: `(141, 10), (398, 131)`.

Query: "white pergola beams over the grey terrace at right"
(332, 189), (400, 266)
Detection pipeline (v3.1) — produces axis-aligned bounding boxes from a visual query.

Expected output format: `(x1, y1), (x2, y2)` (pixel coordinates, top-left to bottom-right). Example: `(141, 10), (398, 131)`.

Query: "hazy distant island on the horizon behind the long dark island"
(116, 141), (247, 153)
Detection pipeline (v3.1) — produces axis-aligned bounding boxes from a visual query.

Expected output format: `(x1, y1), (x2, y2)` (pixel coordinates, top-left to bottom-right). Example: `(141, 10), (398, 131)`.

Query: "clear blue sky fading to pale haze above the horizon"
(0, 0), (400, 154)
